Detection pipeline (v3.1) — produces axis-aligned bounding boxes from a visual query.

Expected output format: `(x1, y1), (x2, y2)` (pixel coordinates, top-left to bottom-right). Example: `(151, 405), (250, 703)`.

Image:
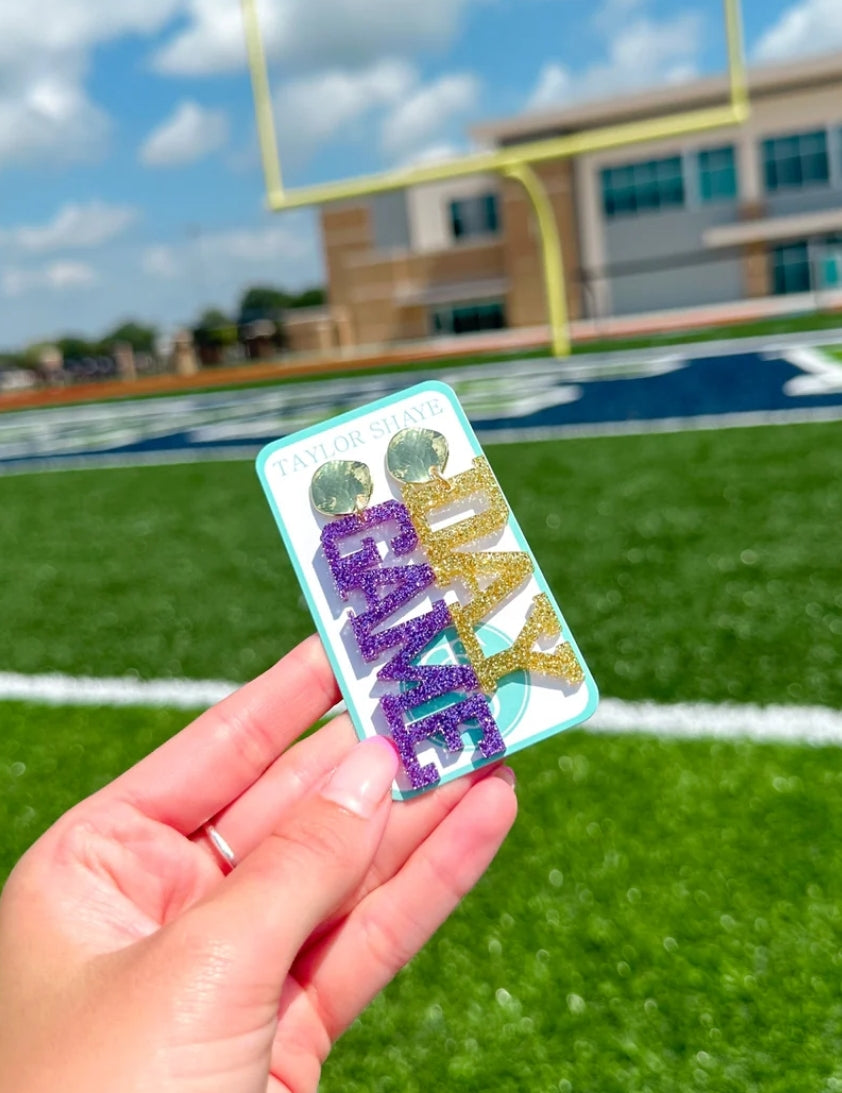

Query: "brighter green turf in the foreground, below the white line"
(6, 704), (842, 1093)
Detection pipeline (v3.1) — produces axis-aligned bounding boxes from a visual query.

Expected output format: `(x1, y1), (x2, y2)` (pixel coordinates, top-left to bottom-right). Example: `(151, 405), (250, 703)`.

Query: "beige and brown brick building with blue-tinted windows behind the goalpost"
(302, 55), (842, 346)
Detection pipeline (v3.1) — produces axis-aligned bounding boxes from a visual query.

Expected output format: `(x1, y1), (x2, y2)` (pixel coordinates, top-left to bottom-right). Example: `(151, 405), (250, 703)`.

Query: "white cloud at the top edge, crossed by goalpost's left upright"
(154, 0), (482, 75)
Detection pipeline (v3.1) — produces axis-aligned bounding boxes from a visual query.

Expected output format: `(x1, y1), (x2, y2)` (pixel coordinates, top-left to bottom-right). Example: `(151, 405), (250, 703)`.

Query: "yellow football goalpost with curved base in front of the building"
(241, 0), (751, 357)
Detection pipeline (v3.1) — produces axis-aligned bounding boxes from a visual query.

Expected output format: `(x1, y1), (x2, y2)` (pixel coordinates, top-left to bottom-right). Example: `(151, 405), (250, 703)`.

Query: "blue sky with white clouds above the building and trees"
(0, 0), (842, 348)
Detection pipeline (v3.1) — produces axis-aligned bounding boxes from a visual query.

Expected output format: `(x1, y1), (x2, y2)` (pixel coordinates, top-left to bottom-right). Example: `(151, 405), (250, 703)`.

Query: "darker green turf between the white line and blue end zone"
(0, 424), (842, 706)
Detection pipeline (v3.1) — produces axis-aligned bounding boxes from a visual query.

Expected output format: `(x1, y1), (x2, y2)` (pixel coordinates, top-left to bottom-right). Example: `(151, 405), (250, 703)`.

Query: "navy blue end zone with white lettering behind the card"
(0, 348), (842, 473)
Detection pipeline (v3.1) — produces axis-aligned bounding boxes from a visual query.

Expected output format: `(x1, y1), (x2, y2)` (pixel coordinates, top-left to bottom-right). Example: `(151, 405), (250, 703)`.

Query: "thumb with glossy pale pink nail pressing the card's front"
(176, 737), (399, 995)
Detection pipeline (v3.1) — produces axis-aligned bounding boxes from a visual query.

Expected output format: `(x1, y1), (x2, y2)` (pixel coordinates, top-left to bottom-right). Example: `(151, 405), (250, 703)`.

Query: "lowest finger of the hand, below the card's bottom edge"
(284, 768), (517, 1040)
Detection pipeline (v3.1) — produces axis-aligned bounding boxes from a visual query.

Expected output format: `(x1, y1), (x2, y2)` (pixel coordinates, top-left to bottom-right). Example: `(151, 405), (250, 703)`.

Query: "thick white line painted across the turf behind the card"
(0, 672), (842, 747)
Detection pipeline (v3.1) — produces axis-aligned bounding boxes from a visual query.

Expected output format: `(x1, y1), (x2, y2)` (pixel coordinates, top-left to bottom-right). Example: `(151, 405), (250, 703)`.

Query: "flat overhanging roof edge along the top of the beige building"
(471, 52), (842, 145)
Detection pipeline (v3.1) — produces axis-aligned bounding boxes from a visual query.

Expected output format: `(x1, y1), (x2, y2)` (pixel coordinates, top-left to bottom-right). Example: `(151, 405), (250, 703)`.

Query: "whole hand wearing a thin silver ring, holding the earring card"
(0, 638), (516, 1093)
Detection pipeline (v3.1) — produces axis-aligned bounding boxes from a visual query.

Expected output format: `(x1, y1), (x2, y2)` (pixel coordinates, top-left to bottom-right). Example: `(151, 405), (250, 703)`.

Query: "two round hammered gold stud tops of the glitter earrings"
(309, 428), (449, 516)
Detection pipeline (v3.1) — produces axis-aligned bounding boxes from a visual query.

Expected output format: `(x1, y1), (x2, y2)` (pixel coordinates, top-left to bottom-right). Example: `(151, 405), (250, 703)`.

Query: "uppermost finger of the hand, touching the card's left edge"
(103, 637), (339, 835)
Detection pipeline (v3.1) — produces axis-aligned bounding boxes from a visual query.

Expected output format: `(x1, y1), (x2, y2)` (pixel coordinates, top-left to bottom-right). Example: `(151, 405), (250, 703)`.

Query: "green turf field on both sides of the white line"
(0, 413), (842, 1093)
